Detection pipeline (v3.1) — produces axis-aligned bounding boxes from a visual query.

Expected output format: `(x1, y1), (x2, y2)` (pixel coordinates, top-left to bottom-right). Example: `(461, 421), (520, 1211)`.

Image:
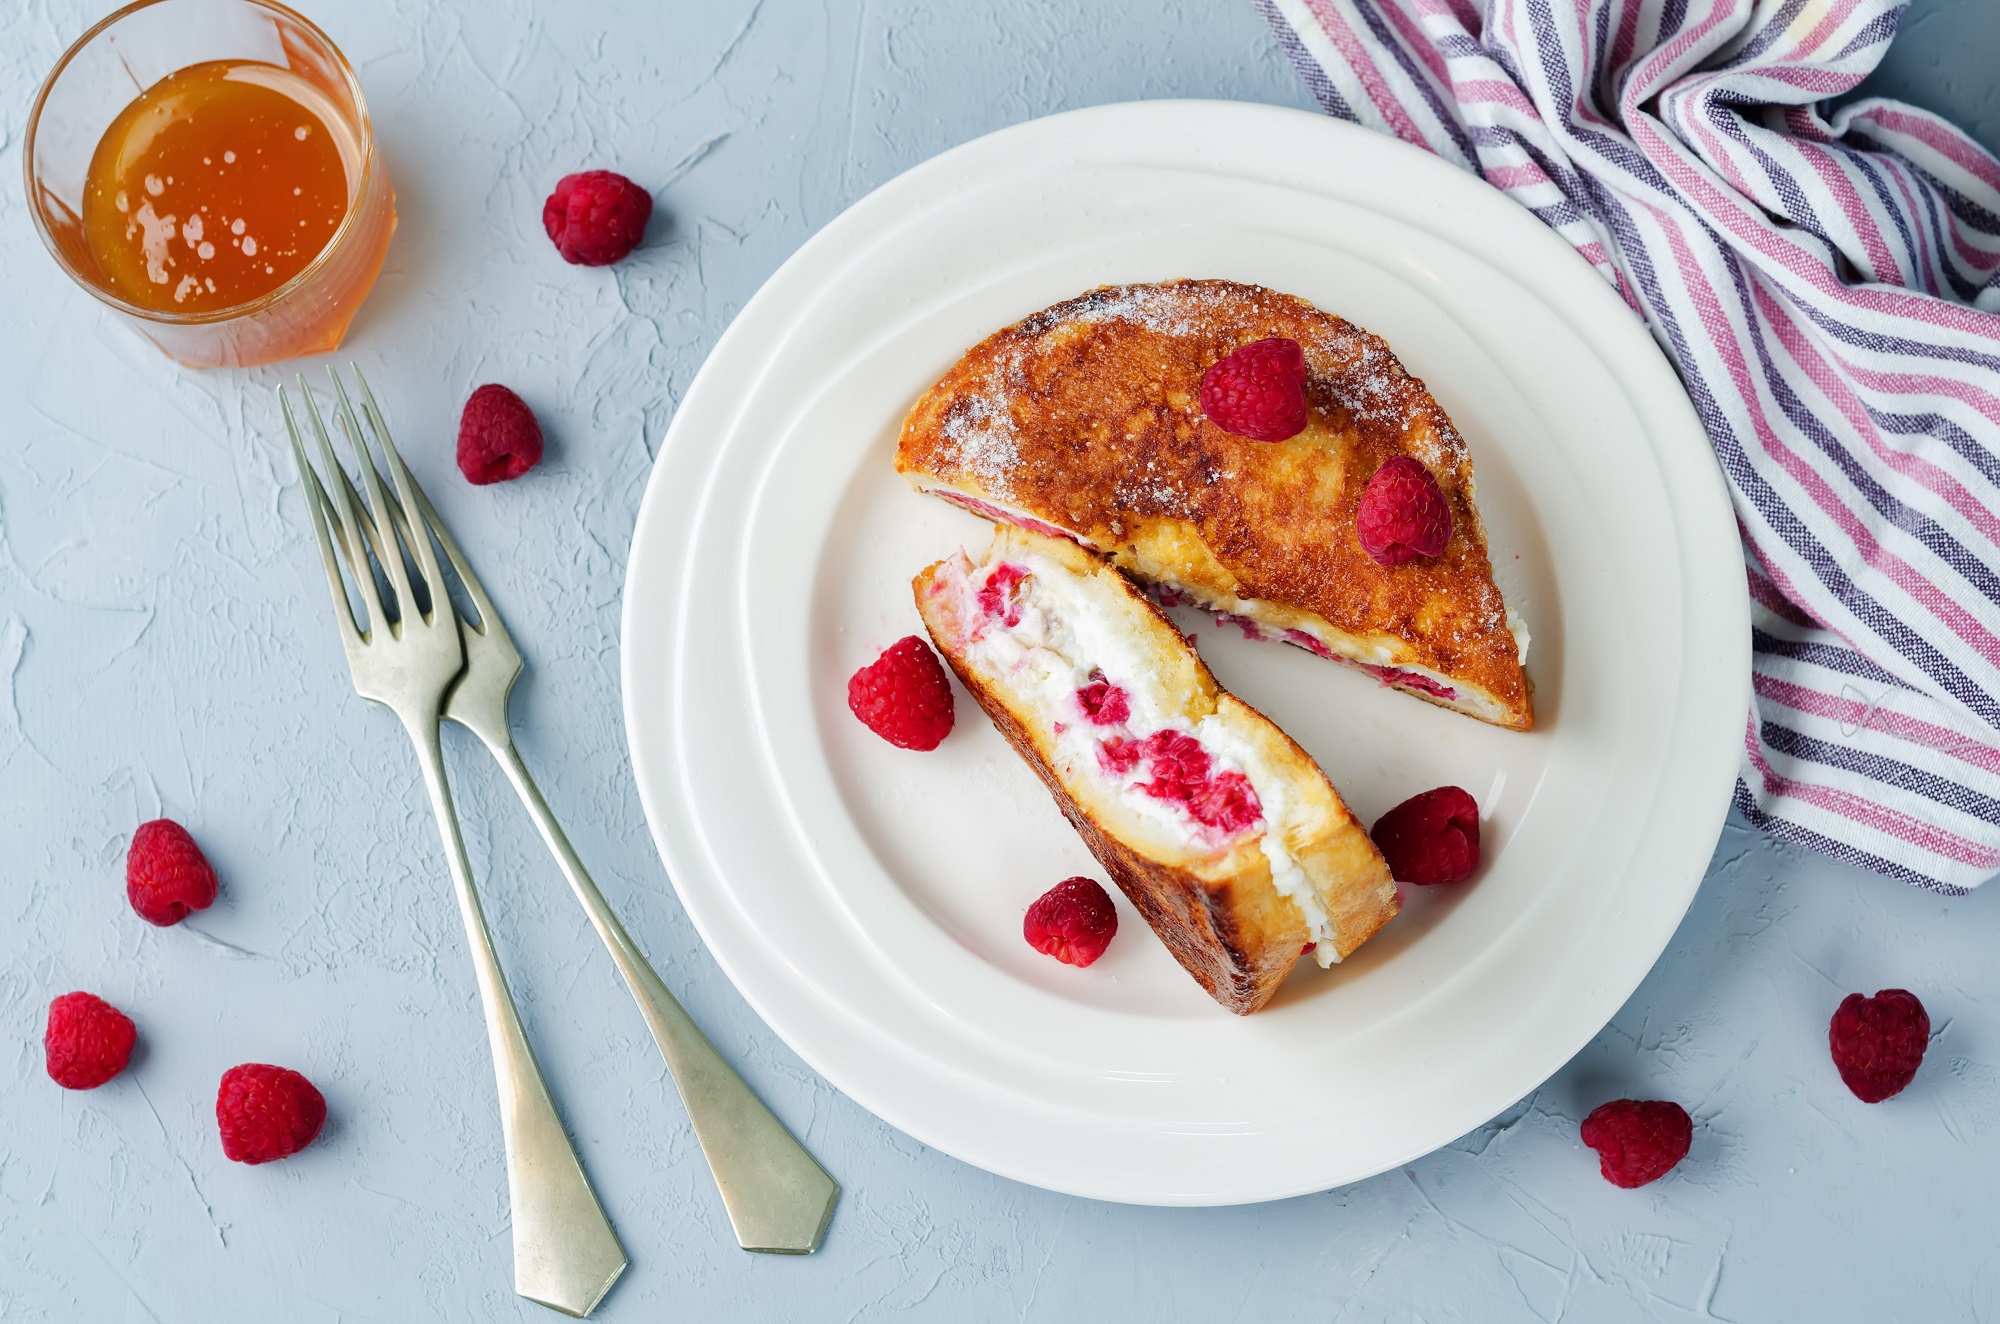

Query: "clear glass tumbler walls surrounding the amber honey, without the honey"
(22, 0), (396, 368)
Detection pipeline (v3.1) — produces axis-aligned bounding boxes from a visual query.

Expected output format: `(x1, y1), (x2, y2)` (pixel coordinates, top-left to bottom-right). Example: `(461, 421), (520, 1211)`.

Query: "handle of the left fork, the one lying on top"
(404, 712), (626, 1316)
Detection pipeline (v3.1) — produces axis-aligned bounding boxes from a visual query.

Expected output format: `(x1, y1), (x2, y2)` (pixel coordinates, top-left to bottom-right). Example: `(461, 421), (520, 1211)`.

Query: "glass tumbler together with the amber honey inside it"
(22, 0), (396, 368)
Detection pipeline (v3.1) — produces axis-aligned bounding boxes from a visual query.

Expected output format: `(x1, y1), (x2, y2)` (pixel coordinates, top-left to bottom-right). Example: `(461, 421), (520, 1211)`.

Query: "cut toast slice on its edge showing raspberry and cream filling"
(912, 526), (1400, 1016)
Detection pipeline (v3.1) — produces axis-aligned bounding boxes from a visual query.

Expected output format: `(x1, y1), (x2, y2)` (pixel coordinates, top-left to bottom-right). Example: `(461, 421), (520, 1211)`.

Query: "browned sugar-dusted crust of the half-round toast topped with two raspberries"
(896, 280), (1534, 730)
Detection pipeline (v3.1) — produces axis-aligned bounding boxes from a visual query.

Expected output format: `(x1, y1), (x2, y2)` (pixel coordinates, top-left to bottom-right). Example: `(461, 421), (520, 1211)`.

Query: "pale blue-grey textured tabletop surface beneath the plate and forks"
(0, 0), (2000, 1322)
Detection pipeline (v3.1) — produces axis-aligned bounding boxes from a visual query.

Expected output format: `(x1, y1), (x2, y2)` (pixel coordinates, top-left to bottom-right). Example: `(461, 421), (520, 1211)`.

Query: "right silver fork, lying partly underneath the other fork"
(342, 368), (840, 1254)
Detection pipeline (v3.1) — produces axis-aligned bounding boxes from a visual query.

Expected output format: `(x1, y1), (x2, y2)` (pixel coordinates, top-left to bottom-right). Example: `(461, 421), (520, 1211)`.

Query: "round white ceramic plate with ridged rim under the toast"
(624, 102), (1750, 1204)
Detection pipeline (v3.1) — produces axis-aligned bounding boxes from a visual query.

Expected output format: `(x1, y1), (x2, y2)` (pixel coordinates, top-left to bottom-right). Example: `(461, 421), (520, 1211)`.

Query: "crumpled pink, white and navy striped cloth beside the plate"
(1256, 0), (2000, 894)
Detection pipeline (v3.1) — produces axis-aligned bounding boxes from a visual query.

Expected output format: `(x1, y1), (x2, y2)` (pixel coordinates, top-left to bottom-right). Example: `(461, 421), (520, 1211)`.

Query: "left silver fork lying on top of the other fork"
(278, 374), (626, 1316)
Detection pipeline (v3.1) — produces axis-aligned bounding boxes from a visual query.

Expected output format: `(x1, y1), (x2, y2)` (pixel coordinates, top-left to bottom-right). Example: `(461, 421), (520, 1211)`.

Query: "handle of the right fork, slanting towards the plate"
(482, 734), (840, 1254)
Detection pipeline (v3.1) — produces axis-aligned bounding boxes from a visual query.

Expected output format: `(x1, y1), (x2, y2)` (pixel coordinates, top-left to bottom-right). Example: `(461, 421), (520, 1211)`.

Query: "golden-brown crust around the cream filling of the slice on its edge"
(912, 528), (1398, 1016)
